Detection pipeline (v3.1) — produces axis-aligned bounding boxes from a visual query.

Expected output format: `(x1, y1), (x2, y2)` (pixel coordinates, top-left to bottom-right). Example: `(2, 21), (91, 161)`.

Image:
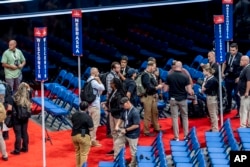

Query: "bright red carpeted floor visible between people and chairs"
(0, 111), (239, 167)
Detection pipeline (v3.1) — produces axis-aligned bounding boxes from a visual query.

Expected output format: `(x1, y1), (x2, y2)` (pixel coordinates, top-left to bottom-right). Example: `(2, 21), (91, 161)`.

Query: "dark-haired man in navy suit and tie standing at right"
(222, 43), (242, 117)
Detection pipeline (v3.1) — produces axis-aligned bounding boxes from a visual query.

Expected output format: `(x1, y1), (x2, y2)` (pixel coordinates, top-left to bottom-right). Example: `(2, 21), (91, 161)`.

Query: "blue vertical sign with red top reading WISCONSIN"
(34, 27), (48, 82)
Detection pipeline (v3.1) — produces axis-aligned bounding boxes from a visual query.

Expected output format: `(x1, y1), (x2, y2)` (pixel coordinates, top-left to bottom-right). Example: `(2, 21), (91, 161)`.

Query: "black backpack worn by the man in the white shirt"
(80, 79), (96, 103)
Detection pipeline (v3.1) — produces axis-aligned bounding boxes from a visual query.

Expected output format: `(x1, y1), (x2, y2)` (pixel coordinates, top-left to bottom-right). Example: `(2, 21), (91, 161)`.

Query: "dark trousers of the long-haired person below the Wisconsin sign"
(13, 121), (29, 152)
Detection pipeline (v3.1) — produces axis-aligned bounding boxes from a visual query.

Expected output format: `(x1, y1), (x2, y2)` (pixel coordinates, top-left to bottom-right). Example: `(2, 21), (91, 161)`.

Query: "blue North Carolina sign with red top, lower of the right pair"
(214, 15), (225, 63)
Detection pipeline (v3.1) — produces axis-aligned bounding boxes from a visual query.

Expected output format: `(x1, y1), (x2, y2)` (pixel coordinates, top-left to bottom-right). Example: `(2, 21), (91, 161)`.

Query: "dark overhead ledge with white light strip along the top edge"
(0, 0), (212, 20)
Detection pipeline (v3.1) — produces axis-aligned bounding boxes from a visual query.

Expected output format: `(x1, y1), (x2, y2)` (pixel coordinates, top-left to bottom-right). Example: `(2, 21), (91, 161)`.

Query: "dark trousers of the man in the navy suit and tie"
(225, 79), (240, 111)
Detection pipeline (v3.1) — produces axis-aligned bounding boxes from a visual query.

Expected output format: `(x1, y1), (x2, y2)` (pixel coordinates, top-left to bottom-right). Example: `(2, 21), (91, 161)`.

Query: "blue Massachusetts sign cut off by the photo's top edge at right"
(222, 0), (233, 41)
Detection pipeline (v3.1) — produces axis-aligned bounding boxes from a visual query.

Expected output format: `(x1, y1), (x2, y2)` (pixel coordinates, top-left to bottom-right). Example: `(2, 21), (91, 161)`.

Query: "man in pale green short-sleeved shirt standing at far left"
(1, 40), (26, 93)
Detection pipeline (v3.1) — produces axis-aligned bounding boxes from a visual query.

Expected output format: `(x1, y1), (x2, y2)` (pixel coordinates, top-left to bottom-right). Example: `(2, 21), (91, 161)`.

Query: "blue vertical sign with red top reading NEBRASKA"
(72, 10), (82, 56)
